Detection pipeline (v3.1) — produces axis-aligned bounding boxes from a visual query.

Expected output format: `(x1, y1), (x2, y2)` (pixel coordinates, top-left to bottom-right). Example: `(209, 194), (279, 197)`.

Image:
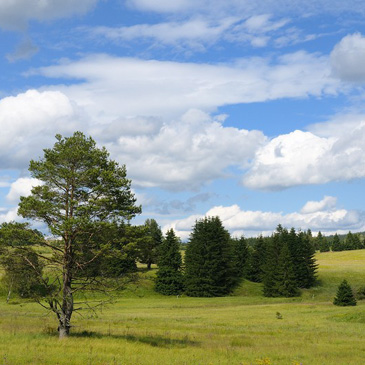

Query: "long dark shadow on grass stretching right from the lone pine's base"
(70, 331), (200, 348)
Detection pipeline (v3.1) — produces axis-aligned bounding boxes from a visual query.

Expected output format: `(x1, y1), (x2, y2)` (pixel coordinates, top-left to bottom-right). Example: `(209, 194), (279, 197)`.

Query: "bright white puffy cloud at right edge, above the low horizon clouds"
(243, 118), (365, 190)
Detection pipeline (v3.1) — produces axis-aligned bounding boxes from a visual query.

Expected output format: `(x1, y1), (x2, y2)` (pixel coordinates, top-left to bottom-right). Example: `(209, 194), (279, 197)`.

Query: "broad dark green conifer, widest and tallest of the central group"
(185, 217), (235, 297)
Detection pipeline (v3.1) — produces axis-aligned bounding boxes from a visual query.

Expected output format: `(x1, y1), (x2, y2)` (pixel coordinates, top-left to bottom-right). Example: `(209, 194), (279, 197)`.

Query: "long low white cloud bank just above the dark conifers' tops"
(163, 197), (365, 239)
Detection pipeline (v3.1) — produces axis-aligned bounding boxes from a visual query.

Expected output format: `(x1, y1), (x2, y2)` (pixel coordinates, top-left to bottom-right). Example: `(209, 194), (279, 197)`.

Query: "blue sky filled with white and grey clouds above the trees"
(0, 0), (365, 240)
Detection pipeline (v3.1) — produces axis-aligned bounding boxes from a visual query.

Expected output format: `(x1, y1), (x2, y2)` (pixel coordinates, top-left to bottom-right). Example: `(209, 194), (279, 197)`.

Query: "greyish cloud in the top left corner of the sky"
(0, 0), (98, 30)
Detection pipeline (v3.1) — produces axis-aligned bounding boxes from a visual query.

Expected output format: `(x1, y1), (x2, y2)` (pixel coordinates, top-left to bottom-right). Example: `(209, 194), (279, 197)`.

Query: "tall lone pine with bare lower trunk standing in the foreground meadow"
(18, 132), (141, 338)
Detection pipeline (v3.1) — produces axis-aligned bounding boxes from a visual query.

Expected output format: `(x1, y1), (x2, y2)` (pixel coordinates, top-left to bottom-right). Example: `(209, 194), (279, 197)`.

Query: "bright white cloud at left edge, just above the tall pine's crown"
(0, 90), (82, 169)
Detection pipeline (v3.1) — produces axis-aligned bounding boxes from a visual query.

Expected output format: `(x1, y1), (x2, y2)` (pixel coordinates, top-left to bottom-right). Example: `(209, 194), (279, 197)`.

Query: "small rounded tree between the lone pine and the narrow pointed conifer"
(138, 219), (163, 270)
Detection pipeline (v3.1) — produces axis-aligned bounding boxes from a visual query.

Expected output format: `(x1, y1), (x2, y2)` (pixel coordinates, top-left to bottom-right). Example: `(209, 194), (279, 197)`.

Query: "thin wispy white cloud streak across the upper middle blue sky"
(86, 14), (290, 52)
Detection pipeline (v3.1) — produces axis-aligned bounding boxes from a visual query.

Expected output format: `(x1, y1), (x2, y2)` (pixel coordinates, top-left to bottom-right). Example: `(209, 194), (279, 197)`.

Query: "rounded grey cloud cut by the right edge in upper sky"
(331, 33), (365, 83)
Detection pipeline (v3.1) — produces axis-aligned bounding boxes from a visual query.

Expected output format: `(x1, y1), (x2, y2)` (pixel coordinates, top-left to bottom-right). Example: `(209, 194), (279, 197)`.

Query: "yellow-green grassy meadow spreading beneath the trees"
(0, 250), (365, 365)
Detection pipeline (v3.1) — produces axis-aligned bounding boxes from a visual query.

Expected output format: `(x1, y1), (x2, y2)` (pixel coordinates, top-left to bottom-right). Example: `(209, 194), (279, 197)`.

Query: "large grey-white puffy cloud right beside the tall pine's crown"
(101, 110), (266, 190)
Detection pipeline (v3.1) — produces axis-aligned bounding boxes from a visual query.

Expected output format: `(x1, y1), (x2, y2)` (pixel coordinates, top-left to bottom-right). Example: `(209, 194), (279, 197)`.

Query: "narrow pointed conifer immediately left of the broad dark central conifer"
(155, 229), (184, 295)
